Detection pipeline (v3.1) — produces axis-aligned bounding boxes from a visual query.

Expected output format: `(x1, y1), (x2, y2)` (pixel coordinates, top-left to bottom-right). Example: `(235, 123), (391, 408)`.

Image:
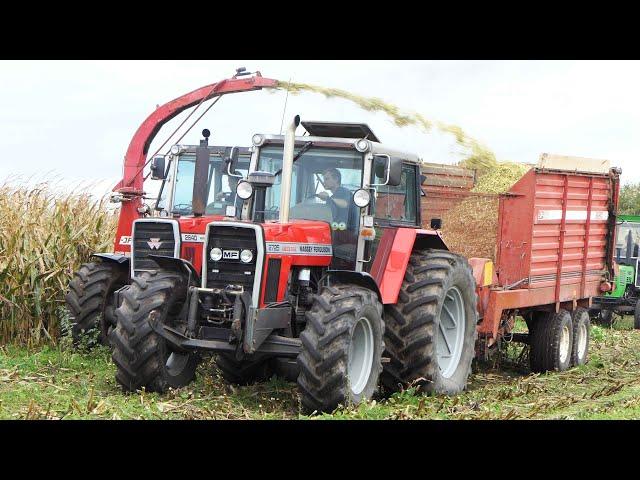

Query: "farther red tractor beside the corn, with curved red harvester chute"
(66, 69), (275, 344)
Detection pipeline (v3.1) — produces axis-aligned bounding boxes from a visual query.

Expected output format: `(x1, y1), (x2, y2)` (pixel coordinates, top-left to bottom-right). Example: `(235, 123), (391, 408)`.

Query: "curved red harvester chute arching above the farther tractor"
(113, 73), (276, 252)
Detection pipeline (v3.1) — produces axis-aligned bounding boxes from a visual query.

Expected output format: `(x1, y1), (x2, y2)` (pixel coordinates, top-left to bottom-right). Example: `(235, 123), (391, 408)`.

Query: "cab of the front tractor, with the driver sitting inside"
(232, 122), (428, 272)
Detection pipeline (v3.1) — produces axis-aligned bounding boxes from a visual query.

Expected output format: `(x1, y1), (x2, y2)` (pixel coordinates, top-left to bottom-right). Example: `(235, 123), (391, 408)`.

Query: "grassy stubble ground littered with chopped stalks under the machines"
(0, 318), (640, 419)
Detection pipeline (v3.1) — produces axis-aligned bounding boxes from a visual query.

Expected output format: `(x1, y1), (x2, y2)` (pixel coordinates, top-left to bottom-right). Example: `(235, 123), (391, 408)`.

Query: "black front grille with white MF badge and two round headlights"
(205, 225), (258, 292)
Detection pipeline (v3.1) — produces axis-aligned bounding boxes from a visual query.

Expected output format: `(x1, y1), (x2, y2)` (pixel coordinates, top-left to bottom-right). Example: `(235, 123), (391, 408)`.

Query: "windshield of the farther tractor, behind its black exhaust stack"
(171, 153), (249, 215)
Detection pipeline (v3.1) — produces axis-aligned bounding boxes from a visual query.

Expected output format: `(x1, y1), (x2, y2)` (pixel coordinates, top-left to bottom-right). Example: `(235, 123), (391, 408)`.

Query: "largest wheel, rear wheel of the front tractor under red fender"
(382, 250), (478, 394)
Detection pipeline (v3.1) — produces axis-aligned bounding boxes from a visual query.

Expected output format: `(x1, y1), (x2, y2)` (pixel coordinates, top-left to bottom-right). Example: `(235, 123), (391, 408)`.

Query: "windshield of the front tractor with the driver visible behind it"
(257, 146), (363, 231)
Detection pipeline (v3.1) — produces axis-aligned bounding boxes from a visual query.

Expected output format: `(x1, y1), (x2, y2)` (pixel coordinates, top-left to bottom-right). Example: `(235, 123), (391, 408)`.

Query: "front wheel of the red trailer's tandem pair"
(529, 310), (573, 372)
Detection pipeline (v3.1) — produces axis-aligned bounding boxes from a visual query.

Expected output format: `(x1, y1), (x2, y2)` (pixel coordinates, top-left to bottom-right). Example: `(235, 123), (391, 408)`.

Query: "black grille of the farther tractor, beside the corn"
(131, 220), (179, 276)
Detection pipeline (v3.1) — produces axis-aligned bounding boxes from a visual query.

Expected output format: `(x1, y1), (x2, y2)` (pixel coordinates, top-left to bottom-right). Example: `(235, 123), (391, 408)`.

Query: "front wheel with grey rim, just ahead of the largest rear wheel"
(297, 285), (384, 413)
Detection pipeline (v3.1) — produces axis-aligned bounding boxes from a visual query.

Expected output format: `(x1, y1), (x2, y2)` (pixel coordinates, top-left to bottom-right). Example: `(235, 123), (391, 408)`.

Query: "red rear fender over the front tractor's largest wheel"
(371, 228), (449, 305)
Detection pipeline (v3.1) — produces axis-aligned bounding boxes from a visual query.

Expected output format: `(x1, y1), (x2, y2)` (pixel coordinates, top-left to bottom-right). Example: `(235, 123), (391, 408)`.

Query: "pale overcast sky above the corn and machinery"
(0, 60), (640, 197)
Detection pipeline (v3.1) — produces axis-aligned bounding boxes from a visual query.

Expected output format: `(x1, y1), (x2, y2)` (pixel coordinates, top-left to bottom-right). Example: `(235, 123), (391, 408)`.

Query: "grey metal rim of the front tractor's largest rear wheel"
(436, 287), (467, 378)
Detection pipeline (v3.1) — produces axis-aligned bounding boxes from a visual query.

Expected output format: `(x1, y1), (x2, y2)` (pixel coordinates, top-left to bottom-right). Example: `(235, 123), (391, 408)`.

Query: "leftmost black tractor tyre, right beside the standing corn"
(65, 262), (128, 345)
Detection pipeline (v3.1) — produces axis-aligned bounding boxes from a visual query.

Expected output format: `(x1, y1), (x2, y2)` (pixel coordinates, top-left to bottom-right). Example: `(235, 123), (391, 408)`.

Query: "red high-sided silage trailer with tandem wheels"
(436, 154), (620, 371)
